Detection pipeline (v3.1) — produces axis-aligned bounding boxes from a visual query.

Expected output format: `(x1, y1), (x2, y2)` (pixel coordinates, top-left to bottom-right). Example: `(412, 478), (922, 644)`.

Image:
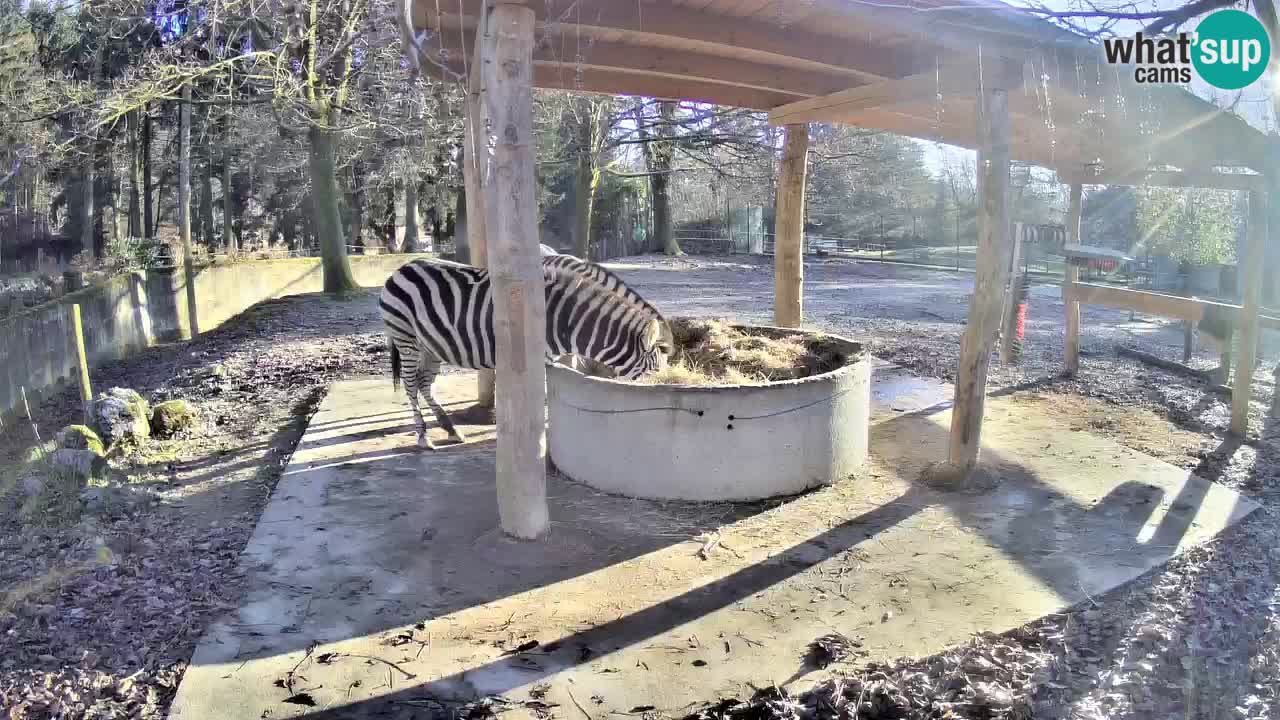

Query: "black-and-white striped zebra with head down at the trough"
(378, 254), (673, 450)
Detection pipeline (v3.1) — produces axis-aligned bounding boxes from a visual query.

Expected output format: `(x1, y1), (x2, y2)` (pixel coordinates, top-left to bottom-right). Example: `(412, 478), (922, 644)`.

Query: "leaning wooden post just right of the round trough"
(947, 87), (1010, 470)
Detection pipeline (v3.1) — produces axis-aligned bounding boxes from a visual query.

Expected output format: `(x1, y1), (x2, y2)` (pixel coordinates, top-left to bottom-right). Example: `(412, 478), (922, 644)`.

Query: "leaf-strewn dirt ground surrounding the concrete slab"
(0, 258), (1280, 719)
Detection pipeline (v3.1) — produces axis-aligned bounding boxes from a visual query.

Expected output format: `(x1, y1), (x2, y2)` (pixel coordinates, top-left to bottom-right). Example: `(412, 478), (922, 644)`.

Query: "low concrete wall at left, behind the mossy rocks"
(0, 255), (426, 425)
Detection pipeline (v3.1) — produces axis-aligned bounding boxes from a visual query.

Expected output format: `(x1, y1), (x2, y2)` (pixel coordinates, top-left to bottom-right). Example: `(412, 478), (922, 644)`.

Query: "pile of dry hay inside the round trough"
(639, 319), (846, 386)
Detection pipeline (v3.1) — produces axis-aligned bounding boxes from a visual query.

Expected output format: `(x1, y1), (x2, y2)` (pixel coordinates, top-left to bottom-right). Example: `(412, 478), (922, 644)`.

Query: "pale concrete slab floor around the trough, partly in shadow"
(170, 368), (1254, 720)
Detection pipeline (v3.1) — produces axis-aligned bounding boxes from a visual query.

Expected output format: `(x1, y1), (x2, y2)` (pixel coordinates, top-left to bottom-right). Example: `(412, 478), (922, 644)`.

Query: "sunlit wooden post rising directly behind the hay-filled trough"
(773, 124), (809, 328)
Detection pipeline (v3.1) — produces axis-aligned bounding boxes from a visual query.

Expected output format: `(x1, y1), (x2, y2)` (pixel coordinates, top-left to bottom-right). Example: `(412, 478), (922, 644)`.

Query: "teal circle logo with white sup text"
(1192, 10), (1271, 90)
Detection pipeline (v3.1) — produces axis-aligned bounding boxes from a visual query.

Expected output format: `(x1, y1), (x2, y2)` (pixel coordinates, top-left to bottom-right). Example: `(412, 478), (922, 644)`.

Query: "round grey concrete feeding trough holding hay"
(547, 325), (872, 501)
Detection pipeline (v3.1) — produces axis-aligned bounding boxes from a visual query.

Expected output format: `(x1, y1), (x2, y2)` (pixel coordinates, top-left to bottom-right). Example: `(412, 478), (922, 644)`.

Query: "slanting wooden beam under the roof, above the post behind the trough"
(769, 63), (1023, 126)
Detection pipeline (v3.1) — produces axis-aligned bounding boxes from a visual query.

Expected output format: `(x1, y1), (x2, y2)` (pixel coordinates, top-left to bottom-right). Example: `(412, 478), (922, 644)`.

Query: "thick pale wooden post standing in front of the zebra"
(480, 4), (548, 539)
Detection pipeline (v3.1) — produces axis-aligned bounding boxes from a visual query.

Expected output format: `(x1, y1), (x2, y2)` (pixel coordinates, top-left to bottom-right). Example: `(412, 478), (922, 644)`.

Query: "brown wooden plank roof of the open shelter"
(407, 0), (1265, 174)
